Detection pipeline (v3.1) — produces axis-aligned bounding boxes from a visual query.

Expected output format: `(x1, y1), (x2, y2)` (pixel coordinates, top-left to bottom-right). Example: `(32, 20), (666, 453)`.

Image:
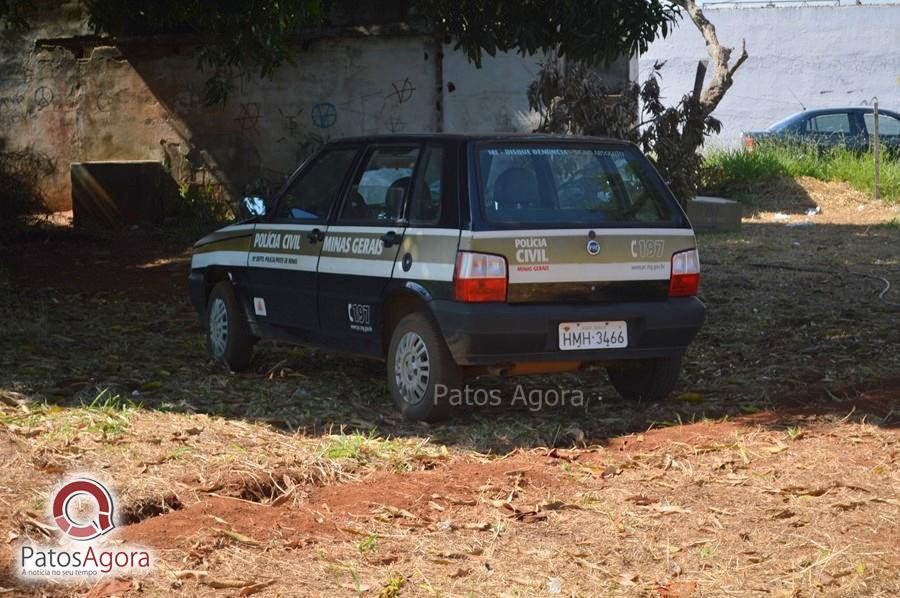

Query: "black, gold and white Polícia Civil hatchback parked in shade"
(190, 134), (705, 421)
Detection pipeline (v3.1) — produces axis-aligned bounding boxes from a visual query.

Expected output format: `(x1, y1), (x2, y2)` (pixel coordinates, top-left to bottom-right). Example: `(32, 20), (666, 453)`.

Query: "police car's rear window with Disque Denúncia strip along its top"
(478, 144), (681, 226)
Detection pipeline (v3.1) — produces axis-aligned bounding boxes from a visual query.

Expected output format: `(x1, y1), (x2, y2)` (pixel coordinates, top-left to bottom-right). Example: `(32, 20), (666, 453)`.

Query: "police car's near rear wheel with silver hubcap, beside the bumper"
(387, 312), (462, 422)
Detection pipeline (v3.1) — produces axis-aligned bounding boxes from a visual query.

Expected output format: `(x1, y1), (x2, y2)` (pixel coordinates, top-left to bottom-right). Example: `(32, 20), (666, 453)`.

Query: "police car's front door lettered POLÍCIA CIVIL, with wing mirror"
(248, 146), (360, 332)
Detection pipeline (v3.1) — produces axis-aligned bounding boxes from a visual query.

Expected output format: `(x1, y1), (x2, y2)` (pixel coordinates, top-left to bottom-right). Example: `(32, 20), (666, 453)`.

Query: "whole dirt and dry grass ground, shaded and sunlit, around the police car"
(0, 179), (900, 596)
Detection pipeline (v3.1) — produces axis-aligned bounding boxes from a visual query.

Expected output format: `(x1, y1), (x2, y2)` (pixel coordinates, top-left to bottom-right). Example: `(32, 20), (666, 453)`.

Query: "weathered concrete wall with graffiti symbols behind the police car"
(0, 5), (634, 210)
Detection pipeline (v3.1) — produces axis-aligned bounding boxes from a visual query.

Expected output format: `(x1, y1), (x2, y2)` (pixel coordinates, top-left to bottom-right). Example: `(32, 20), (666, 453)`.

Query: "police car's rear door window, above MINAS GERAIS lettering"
(338, 146), (419, 223)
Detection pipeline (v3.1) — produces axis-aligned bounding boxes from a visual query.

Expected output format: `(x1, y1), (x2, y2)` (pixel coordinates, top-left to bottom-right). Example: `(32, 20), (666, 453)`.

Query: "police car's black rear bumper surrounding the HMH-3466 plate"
(432, 297), (706, 365)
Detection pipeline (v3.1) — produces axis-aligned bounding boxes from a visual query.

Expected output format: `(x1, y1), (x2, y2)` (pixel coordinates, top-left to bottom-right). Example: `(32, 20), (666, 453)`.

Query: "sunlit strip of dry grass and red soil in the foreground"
(0, 400), (900, 596)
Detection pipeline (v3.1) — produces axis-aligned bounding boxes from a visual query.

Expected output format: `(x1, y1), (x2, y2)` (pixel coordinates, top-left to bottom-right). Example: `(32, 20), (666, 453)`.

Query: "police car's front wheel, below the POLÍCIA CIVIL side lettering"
(206, 281), (256, 372)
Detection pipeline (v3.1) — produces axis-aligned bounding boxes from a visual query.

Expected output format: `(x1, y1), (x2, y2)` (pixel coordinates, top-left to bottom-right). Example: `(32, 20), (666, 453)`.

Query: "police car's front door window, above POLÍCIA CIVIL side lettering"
(275, 148), (358, 220)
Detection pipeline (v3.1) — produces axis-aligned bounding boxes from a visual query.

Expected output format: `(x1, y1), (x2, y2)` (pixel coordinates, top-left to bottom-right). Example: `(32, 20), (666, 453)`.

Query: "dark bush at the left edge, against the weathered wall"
(0, 140), (55, 238)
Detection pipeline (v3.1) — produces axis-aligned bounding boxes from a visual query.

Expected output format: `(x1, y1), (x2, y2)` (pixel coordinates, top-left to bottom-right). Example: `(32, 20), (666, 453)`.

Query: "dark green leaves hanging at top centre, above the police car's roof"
(414, 0), (680, 66)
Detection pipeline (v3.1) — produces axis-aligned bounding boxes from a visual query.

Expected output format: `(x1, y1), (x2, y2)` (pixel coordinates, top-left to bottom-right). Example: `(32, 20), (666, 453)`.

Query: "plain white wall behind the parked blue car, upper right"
(640, 5), (900, 146)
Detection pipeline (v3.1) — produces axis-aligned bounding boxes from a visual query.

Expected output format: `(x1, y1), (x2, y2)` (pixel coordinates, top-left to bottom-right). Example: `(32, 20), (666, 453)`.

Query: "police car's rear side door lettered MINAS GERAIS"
(318, 144), (421, 353)
